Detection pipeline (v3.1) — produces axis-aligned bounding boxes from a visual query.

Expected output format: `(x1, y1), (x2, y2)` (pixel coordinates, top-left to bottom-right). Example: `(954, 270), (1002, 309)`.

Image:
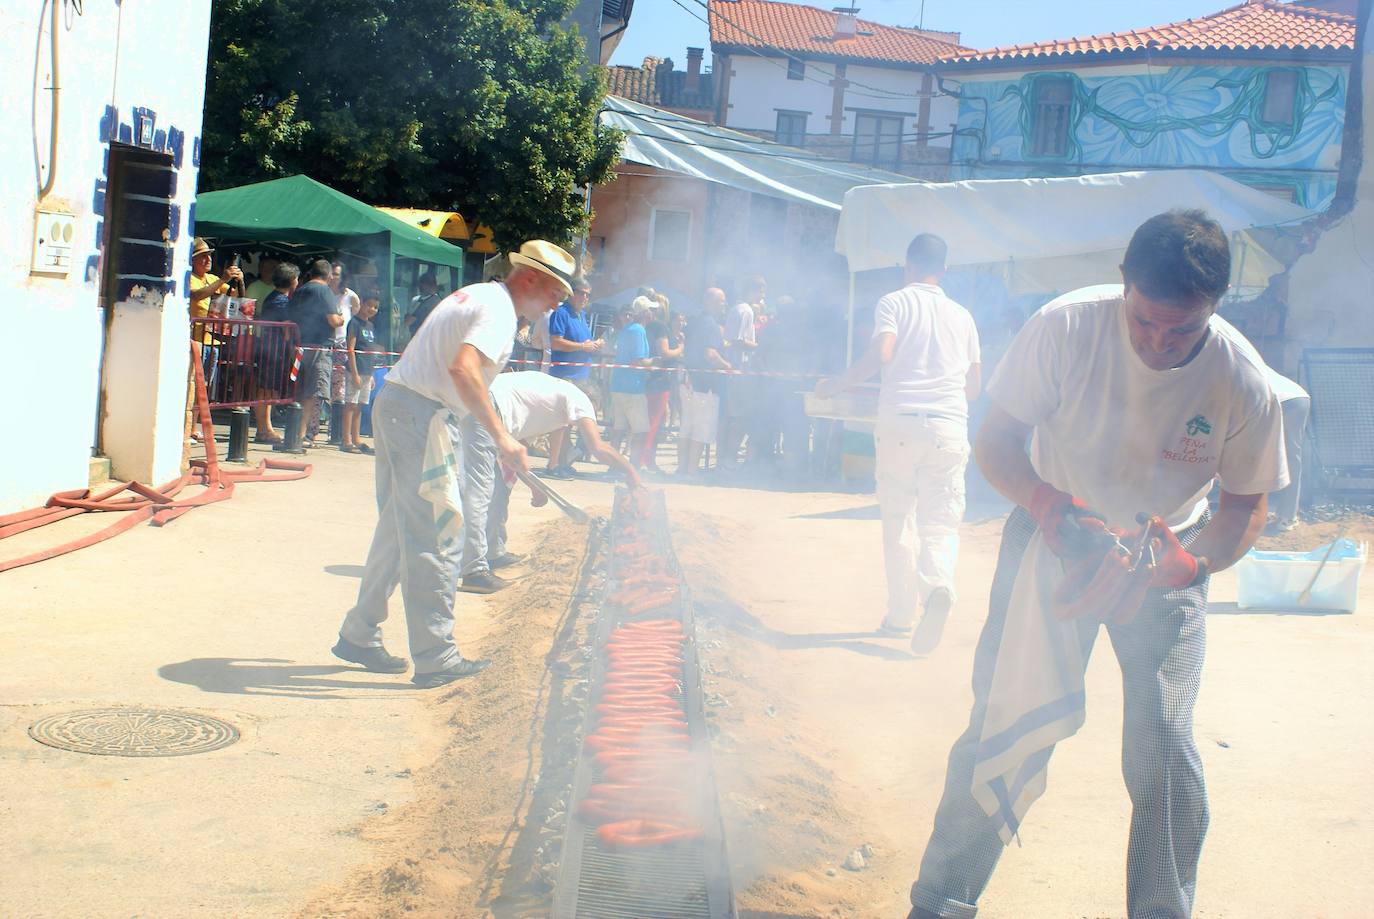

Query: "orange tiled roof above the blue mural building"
(945, 0), (1355, 63)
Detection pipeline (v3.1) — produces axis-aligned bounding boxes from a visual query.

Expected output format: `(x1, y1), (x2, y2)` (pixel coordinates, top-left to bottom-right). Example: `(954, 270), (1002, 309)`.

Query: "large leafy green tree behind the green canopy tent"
(201, 0), (621, 247)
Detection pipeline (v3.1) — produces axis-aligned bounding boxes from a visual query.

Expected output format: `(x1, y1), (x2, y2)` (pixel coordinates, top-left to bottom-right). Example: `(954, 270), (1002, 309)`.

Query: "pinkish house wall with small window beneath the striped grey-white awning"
(588, 163), (709, 298)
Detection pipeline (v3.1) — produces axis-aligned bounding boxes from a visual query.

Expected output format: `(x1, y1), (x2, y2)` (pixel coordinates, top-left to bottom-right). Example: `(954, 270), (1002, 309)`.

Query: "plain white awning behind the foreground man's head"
(835, 169), (1312, 290)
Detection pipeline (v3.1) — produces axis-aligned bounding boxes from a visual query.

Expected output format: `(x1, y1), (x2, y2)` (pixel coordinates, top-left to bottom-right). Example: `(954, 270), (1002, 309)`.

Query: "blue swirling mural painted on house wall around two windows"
(951, 66), (1347, 207)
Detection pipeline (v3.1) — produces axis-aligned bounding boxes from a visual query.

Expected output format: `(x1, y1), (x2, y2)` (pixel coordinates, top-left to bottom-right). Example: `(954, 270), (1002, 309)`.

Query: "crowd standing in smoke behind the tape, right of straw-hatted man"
(515, 270), (845, 481)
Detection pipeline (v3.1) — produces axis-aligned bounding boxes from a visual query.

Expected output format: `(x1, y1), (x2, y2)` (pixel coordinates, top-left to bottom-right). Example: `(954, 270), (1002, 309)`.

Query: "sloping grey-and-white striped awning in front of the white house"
(600, 96), (912, 210)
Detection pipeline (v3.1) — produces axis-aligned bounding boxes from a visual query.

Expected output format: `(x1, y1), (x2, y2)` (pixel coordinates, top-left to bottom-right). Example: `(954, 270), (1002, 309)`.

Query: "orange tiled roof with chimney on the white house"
(708, 0), (970, 65)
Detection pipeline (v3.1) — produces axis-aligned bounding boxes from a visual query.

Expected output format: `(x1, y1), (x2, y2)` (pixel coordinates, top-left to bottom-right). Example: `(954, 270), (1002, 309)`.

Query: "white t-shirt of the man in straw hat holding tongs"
(386, 282), (515, 418)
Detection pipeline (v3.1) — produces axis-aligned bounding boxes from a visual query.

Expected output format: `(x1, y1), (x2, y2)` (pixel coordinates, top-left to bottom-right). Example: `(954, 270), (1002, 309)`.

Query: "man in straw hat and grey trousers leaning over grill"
(334, 240), (576, 688)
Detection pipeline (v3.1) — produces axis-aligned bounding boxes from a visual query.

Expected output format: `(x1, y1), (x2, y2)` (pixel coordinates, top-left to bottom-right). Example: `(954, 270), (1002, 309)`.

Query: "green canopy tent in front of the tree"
(194, 176), (463, 345)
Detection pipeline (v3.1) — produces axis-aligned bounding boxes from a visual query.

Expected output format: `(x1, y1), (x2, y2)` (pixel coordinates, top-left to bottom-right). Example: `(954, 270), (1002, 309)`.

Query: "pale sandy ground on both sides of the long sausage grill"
(0, 439), (1374, 919)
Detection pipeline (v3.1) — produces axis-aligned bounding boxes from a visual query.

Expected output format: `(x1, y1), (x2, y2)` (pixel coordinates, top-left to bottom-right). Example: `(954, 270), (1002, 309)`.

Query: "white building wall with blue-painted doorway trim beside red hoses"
(0, 0), (210, 512)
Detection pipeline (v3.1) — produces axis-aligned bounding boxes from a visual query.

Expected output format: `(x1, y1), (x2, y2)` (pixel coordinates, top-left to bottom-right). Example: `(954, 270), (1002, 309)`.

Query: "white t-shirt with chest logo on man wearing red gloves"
(988, 289), (1287, 530)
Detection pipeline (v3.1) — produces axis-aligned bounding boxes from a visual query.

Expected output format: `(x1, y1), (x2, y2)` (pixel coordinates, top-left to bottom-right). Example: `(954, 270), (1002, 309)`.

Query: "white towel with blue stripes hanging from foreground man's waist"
(973, 533), (1085, 843)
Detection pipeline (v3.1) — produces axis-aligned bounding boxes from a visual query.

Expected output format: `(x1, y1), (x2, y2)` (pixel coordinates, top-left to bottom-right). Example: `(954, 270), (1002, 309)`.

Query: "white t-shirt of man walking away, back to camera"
(872, 284), (982, 419)
